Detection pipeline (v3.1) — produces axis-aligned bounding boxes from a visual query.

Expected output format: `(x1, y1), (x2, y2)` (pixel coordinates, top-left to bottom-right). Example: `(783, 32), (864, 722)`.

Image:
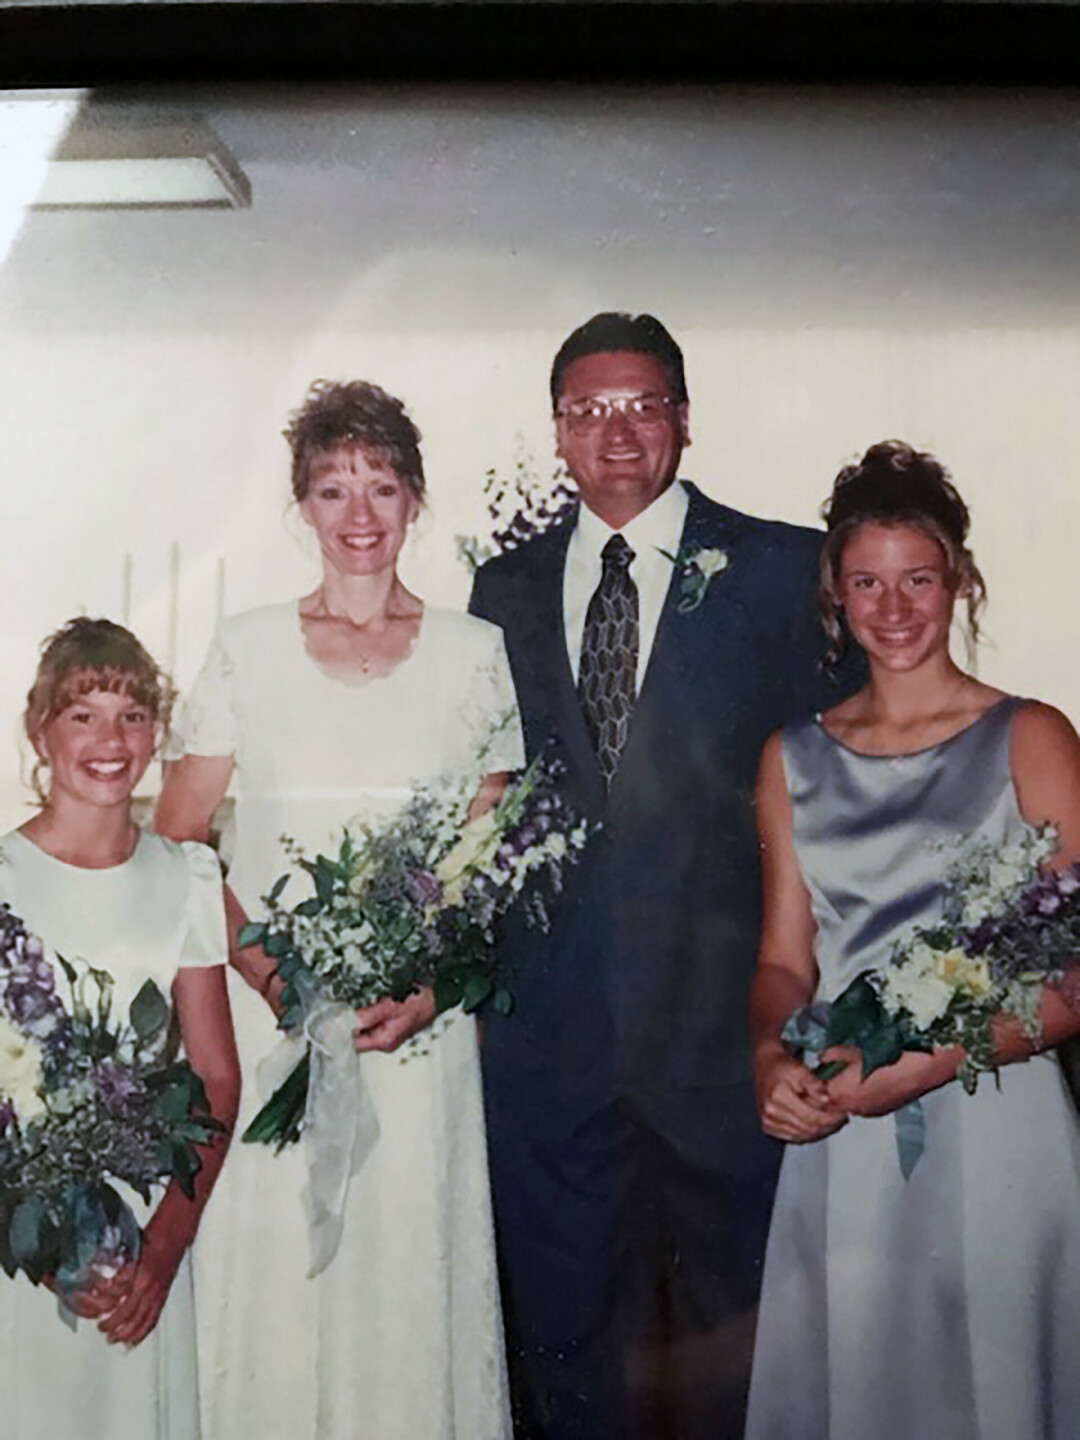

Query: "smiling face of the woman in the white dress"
(300, 445), (420, 575)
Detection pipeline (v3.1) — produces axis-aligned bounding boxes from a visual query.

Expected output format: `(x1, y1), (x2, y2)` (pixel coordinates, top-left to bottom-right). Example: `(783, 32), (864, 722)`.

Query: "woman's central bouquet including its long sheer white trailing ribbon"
(239, 726), (588, 1274)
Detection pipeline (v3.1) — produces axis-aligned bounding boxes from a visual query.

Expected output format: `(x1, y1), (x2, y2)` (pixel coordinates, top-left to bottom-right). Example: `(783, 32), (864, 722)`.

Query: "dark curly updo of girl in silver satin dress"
(818, 441), (986, 668)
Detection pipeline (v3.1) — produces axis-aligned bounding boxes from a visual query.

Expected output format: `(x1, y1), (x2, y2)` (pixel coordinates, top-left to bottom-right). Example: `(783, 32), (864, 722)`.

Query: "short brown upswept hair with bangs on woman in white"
(282, 380), (426, 504)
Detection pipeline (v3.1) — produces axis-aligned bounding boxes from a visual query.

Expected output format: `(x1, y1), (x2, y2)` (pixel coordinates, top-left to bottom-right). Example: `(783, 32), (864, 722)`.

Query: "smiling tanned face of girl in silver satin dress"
(838, 521), (958, 671)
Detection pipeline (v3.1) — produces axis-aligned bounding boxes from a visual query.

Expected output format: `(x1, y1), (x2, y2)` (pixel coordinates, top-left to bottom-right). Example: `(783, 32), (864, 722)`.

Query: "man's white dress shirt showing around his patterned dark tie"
(563, 481), (690, 694)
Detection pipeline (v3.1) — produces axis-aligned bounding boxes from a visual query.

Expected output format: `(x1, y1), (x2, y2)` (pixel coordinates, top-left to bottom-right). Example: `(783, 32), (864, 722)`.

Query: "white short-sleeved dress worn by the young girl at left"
(0, 831), (226, 1440)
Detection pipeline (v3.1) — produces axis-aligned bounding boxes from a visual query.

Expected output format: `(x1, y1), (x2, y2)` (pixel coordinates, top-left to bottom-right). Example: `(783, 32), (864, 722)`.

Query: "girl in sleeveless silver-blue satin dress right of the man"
(747, 441), (1080, 1440)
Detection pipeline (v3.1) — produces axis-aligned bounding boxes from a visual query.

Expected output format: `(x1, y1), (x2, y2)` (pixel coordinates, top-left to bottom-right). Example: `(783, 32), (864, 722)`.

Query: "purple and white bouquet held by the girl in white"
(0, 904), (222, 1318)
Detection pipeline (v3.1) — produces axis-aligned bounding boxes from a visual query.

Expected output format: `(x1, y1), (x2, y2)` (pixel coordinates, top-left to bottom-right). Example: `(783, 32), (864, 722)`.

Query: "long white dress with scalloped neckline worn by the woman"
(173, 602), (523, 1440)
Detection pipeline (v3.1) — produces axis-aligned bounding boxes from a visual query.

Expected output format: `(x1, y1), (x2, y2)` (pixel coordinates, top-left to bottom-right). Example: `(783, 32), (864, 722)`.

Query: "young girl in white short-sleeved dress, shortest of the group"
(0, 618), (239, 1440)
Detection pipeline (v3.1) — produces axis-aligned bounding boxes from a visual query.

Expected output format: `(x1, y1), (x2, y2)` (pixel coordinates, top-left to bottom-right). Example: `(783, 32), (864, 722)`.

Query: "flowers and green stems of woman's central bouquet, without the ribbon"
(239, 757), (586, 1151)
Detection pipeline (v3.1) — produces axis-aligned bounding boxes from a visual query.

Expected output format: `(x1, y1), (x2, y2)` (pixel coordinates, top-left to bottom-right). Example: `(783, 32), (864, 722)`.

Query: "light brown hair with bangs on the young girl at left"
(23, 615), (174, 801)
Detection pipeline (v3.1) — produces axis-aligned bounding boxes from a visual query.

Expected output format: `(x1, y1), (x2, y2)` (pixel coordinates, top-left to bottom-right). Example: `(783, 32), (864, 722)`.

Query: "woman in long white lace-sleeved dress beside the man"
(157, 382), (523, 1440)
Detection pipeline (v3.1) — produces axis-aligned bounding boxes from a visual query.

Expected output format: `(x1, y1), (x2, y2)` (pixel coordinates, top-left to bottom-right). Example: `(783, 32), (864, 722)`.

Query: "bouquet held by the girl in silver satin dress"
(782, 825), (1080, 1176)
